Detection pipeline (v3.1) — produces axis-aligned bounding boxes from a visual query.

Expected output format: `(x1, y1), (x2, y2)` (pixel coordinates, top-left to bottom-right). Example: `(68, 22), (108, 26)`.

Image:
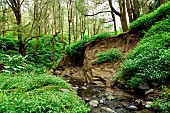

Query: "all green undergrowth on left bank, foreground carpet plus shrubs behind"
(0, 36), (90, 113)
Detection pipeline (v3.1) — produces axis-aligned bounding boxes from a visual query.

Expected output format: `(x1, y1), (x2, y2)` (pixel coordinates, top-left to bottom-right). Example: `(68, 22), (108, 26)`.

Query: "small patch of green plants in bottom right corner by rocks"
(153, 88), (170, 113)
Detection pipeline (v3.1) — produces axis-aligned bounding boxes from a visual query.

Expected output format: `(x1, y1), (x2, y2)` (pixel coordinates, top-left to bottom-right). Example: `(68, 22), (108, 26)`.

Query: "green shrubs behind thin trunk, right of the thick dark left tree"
(26, 35), (63, 67)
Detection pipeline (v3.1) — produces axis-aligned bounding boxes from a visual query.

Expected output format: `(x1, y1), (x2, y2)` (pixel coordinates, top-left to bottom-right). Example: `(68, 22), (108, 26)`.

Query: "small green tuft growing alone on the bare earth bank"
(96, 48), (122, 64)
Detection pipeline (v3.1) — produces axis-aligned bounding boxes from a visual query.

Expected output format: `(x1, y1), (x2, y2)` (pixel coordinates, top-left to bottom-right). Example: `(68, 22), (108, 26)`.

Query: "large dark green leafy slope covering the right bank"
(120, 2), (170, 88)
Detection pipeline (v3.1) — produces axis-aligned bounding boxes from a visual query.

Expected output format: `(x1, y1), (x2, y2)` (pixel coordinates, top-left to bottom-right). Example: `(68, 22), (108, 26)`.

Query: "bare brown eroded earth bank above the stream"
(54, 31), (141, 86)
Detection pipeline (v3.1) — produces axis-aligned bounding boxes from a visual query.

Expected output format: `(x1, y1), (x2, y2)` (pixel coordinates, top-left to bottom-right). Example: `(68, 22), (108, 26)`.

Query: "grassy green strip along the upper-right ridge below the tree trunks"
(130, 2), (170, 30)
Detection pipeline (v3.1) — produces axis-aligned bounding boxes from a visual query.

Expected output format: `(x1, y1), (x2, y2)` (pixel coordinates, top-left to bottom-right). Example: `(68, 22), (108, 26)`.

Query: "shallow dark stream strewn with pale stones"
(67, 79), (160, 113)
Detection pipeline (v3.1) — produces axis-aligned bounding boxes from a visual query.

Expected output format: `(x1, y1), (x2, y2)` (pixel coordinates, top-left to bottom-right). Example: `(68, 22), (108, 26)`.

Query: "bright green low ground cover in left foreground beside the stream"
(0, 73), (89, 113)
